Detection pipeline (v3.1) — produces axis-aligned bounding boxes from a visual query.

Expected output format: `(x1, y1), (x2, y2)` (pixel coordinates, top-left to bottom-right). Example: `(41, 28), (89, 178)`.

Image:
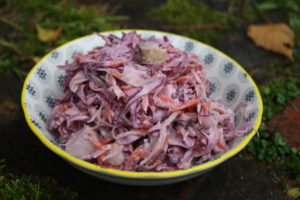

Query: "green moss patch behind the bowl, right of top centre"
(149, 0), (229, 43)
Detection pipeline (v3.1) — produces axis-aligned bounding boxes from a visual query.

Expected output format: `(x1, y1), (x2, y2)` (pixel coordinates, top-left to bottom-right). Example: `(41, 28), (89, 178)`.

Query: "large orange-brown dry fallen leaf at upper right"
(247, 23), (295, 60)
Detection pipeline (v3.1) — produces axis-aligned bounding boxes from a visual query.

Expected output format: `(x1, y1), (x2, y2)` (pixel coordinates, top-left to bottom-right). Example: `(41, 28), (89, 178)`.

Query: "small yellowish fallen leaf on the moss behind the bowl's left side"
(36, 24), (62, 42)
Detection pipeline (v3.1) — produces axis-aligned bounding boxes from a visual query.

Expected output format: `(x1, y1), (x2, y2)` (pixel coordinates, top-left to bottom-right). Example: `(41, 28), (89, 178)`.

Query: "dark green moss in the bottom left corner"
(0, 160), (77, 200)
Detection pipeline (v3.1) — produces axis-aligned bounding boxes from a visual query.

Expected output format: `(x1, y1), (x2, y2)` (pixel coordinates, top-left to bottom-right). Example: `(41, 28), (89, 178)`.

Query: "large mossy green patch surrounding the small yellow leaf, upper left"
(0, 0), (123, 77)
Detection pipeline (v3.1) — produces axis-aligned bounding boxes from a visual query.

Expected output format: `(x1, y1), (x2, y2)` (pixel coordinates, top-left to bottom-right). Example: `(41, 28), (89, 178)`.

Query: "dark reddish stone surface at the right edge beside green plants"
(269, 96), (300, 148)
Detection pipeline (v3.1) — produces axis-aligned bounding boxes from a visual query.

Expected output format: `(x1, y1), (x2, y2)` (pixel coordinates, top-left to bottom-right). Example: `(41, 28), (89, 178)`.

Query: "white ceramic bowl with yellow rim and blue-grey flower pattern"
(22, 30), (263, 185)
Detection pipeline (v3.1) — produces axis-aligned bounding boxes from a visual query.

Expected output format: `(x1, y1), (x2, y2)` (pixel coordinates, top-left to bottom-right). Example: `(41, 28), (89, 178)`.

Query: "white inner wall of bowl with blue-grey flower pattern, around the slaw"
(23, 30), (262, 175)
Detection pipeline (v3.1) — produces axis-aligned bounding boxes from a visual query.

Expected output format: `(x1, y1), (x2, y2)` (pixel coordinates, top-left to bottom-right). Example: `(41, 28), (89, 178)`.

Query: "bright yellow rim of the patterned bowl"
(21, 29), (263, 179)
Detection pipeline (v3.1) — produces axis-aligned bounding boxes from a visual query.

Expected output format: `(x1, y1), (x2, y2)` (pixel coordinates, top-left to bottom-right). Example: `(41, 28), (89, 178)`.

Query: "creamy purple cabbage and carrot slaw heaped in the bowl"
(49, 32), (250, 171)
